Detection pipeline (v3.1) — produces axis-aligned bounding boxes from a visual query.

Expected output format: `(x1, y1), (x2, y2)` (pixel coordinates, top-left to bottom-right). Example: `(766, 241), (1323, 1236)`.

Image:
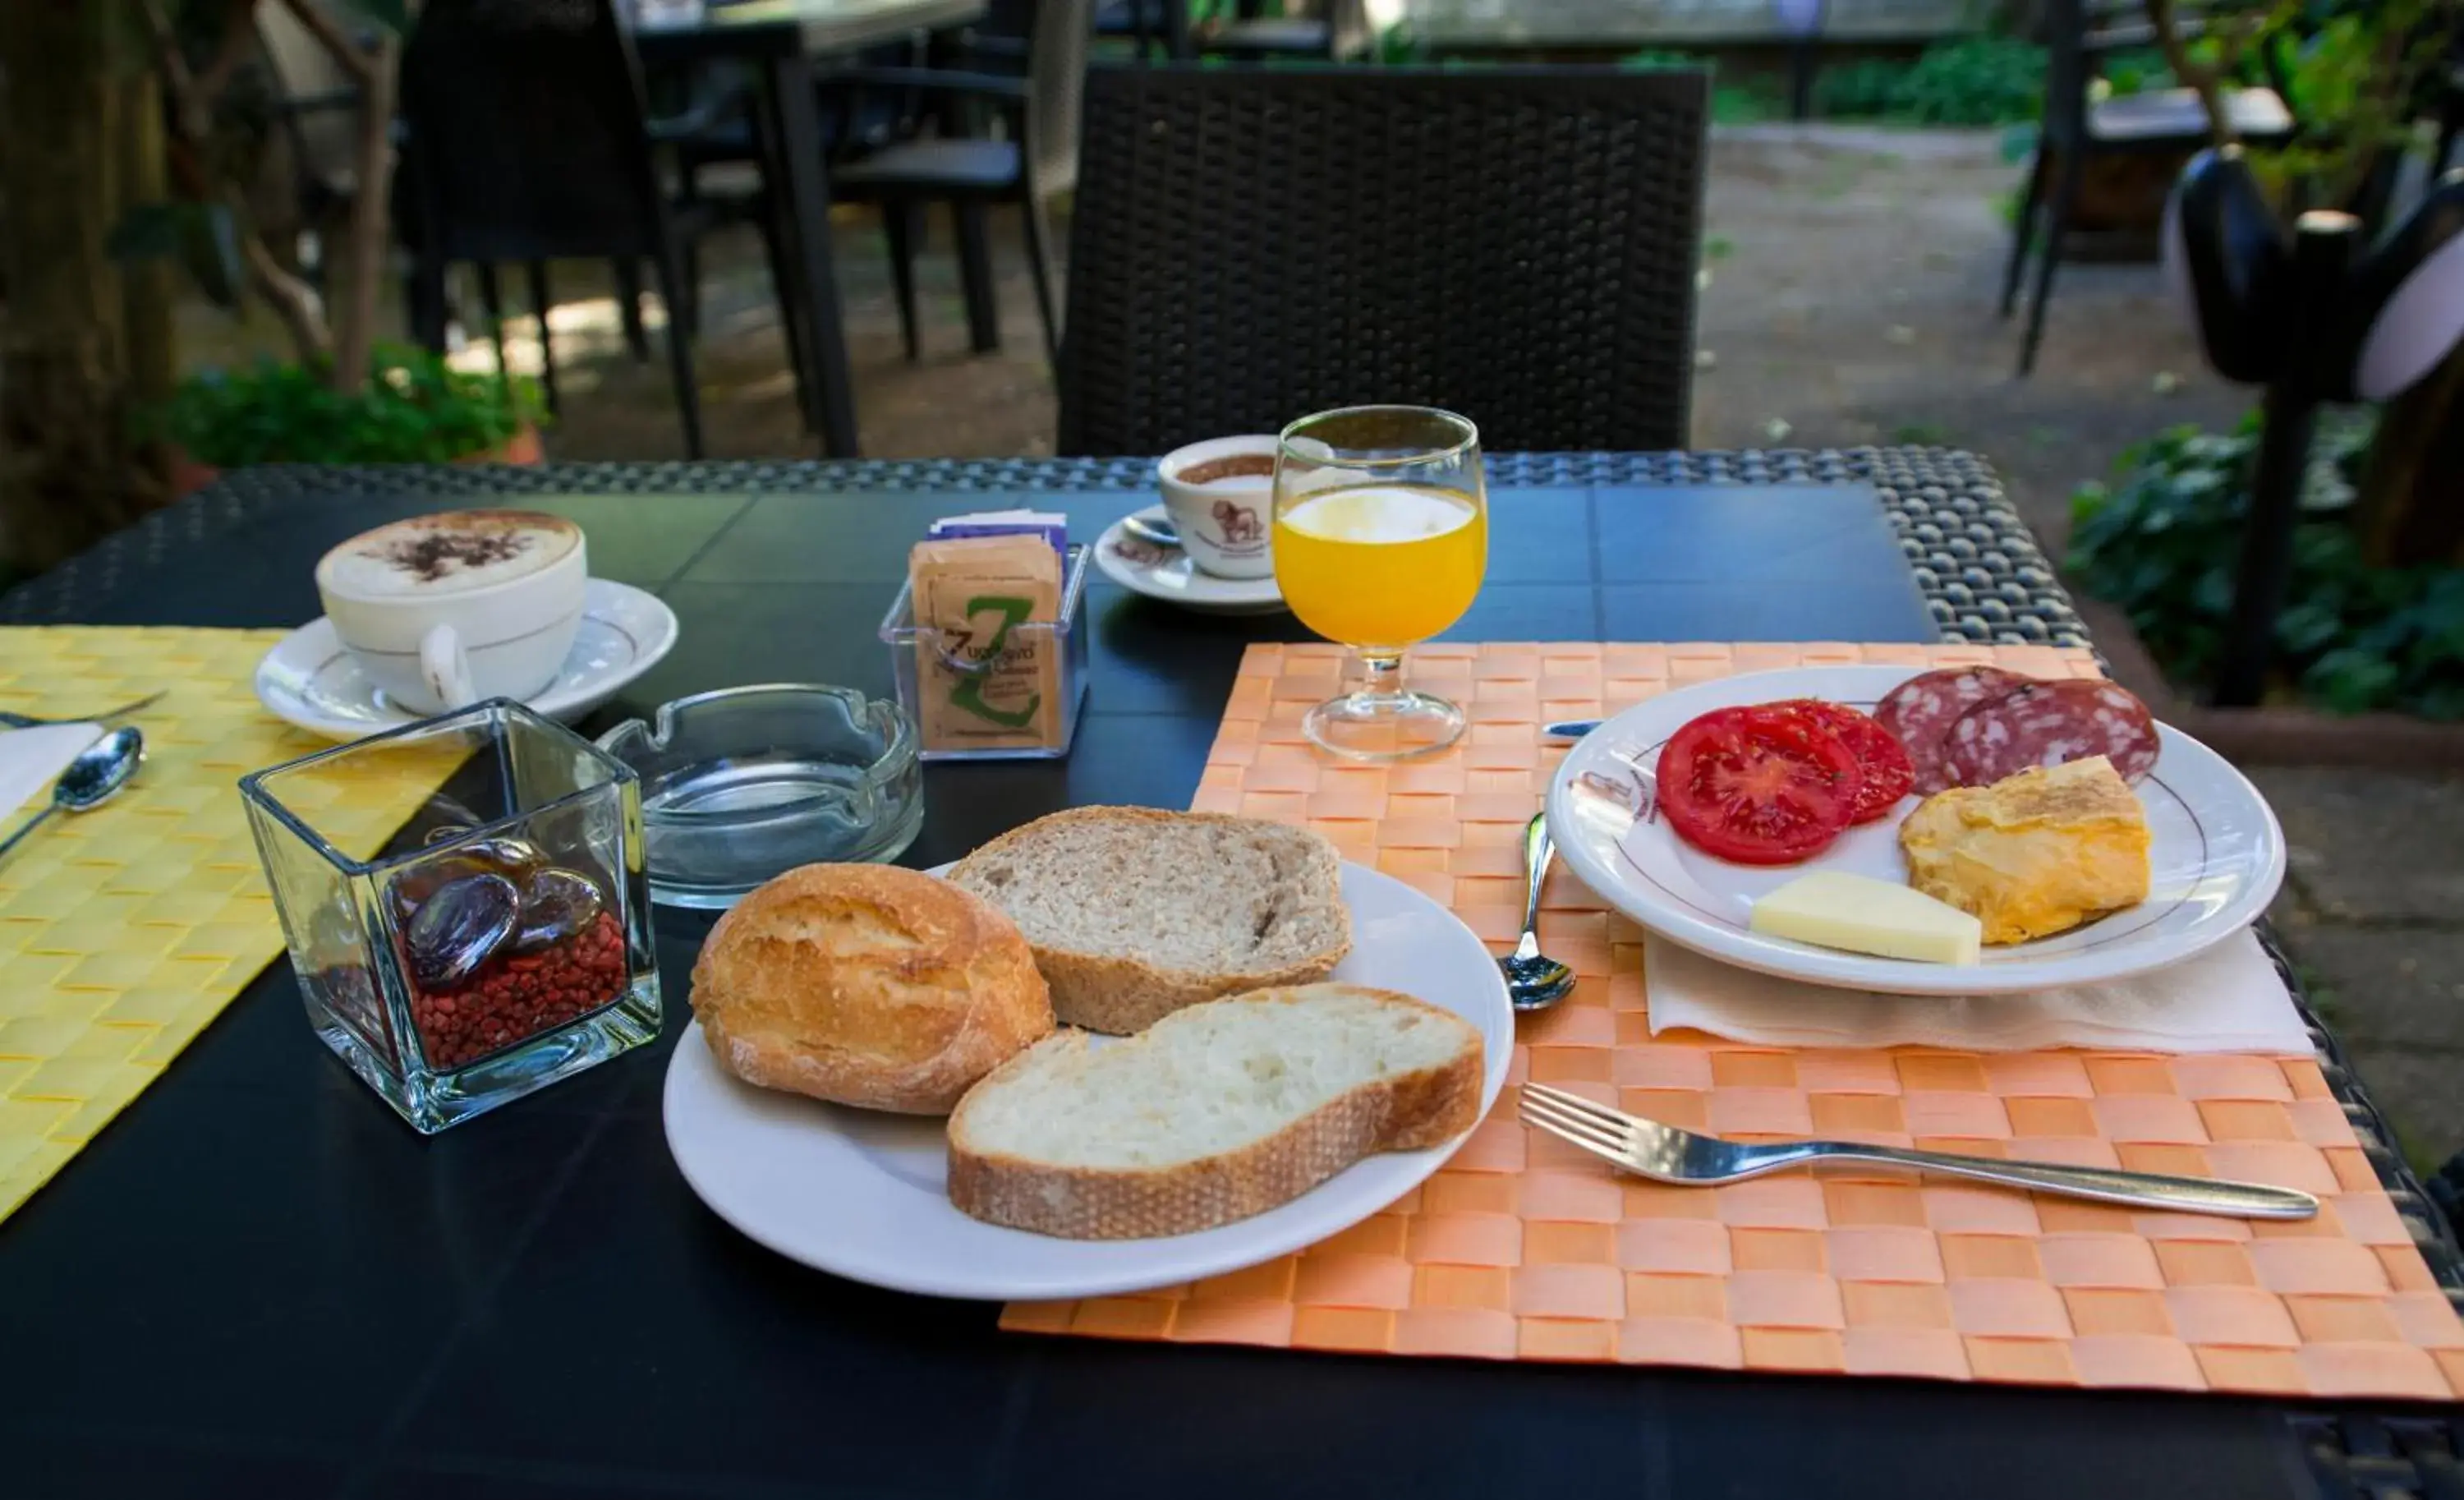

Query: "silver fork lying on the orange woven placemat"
(1520, 1084), (2319, 1219)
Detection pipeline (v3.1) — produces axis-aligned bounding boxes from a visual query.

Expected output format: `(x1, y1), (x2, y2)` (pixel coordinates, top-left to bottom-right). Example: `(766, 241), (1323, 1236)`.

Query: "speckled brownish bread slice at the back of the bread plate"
(949, 808), (1353, 1037)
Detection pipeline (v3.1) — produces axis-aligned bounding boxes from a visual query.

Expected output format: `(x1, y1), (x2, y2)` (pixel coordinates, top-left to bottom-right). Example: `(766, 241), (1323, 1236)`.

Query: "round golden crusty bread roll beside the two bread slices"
(692, 864), (1052, 1116)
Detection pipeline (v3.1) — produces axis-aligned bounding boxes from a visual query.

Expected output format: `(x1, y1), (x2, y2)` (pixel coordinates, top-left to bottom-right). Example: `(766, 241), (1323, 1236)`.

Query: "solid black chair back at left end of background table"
(402, 0), (665, 261)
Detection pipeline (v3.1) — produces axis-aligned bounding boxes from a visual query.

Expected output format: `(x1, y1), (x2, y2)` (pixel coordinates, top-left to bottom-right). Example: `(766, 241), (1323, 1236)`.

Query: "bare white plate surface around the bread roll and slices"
(665, 864), (1515, 1298)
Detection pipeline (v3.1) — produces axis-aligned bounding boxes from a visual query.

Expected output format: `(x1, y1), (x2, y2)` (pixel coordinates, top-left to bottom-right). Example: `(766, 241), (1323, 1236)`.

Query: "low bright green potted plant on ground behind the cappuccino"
(153, 345), (542, 468)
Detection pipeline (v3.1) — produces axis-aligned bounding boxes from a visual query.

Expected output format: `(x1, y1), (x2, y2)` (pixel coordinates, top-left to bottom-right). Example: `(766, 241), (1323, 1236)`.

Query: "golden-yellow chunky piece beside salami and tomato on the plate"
(1900, 756), (2149, 943)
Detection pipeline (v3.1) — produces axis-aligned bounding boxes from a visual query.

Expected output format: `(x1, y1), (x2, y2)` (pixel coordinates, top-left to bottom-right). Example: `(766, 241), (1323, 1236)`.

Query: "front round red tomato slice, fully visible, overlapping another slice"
(1658, 707), (1863, 864)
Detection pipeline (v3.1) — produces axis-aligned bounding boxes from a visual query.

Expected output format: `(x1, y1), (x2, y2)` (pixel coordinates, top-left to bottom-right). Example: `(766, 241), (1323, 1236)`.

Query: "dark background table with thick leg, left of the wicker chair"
(633, 0), (983, 458)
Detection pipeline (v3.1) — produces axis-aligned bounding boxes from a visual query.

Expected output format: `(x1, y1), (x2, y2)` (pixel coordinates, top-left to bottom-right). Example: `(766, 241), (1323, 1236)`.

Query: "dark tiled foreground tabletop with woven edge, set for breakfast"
(0, 451), (2464, 1500)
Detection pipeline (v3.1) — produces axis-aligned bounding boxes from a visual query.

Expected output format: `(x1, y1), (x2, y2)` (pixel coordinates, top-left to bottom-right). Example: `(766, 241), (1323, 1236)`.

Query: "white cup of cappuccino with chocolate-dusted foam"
(315, 510), (589, 715)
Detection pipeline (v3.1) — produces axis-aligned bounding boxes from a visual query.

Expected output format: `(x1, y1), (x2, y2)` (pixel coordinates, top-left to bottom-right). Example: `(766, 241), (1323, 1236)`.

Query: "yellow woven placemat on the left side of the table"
(0, 626), (451, 1219)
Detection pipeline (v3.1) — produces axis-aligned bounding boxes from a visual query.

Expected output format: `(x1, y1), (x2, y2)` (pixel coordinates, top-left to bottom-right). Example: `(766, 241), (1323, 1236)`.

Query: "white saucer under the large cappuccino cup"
(256, 579), (675, 739)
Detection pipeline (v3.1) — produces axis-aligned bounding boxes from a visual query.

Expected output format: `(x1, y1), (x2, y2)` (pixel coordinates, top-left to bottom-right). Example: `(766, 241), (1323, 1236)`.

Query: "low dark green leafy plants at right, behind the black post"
(2067, 416), (2464, 720)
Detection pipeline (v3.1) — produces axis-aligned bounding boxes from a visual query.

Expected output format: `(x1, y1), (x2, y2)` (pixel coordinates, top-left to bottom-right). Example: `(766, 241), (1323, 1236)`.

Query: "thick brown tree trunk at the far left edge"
(0, 0), (170, 569)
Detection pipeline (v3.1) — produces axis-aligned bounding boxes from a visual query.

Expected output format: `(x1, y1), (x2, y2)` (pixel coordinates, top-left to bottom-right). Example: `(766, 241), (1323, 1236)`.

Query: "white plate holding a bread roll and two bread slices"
(665, 808), (1513, 1300)
